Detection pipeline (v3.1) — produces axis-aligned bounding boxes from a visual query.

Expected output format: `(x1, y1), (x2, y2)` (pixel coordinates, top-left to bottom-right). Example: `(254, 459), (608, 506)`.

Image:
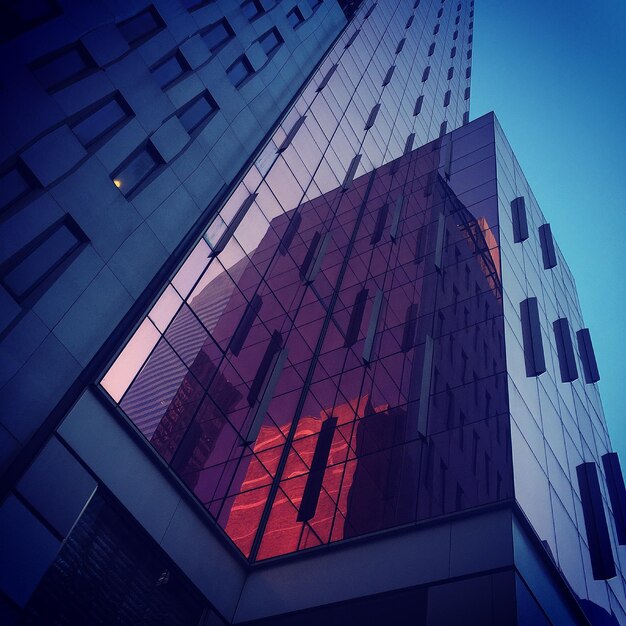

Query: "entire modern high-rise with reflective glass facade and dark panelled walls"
(0, 0), (626, 626)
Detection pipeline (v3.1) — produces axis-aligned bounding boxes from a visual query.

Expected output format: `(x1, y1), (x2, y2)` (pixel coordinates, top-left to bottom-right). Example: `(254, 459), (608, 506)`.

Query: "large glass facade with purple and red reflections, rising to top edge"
(102, 2), (472, 559)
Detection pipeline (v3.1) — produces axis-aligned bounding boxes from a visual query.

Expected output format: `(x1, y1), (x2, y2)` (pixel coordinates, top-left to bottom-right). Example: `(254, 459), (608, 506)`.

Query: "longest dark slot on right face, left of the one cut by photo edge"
(576, 463), (615, 580)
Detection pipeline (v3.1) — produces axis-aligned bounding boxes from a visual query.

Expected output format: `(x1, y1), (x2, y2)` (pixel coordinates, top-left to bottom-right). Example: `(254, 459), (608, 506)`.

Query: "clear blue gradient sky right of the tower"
(471, 0), (626, 458)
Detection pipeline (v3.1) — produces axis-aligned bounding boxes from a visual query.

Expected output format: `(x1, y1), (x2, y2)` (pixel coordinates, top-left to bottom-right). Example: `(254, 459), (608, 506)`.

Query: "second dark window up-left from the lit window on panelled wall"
(30, 42), (97, 93)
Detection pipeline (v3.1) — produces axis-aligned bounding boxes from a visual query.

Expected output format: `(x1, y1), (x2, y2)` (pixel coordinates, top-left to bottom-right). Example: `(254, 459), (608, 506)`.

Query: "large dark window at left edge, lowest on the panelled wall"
(0, 216), (88, 302)
